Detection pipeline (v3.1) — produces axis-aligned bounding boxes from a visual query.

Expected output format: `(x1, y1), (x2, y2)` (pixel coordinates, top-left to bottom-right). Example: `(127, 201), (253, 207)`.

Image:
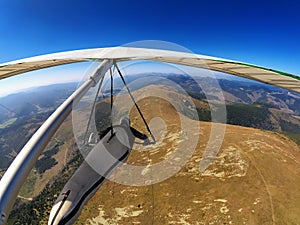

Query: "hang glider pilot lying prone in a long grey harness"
(48, 118), (150, 225)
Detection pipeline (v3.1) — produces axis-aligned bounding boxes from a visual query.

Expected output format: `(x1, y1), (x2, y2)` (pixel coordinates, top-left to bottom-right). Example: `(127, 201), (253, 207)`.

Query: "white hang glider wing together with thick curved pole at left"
(0, 47), (300, 224)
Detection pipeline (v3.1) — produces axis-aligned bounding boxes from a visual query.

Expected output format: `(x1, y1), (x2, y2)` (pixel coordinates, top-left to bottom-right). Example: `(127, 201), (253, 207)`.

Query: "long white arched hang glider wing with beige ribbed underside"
(0, 47), (300, 93)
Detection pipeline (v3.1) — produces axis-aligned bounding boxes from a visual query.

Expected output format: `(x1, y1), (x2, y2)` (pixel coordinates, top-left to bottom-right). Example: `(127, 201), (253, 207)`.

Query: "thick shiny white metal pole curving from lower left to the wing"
(0, 59), (113, 225)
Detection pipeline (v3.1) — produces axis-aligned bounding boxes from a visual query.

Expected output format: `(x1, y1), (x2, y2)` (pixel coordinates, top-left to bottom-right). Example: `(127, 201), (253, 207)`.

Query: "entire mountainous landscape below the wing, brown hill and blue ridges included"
(0, 74), (300, 224)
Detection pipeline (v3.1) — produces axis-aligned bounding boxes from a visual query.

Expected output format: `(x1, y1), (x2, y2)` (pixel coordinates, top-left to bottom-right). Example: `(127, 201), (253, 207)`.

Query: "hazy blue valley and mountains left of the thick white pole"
(0, 83), (77, 171)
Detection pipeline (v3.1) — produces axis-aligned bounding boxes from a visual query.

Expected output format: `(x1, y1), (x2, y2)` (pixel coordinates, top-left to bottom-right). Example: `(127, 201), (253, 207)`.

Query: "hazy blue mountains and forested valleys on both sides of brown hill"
(0, 73), (300, 171)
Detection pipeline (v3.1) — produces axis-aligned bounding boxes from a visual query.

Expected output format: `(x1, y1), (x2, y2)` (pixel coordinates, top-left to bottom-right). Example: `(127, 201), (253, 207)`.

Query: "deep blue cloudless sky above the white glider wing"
(0, 0), (300, 95)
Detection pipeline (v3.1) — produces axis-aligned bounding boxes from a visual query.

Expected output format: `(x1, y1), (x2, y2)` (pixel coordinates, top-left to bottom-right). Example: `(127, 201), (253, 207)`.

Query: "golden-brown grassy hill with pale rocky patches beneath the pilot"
(76, 86), (300, 224)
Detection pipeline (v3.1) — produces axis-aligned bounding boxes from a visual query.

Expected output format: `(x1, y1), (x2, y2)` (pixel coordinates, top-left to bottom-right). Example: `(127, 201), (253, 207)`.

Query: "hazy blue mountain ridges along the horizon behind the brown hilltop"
(115, 73), (300, 116)
